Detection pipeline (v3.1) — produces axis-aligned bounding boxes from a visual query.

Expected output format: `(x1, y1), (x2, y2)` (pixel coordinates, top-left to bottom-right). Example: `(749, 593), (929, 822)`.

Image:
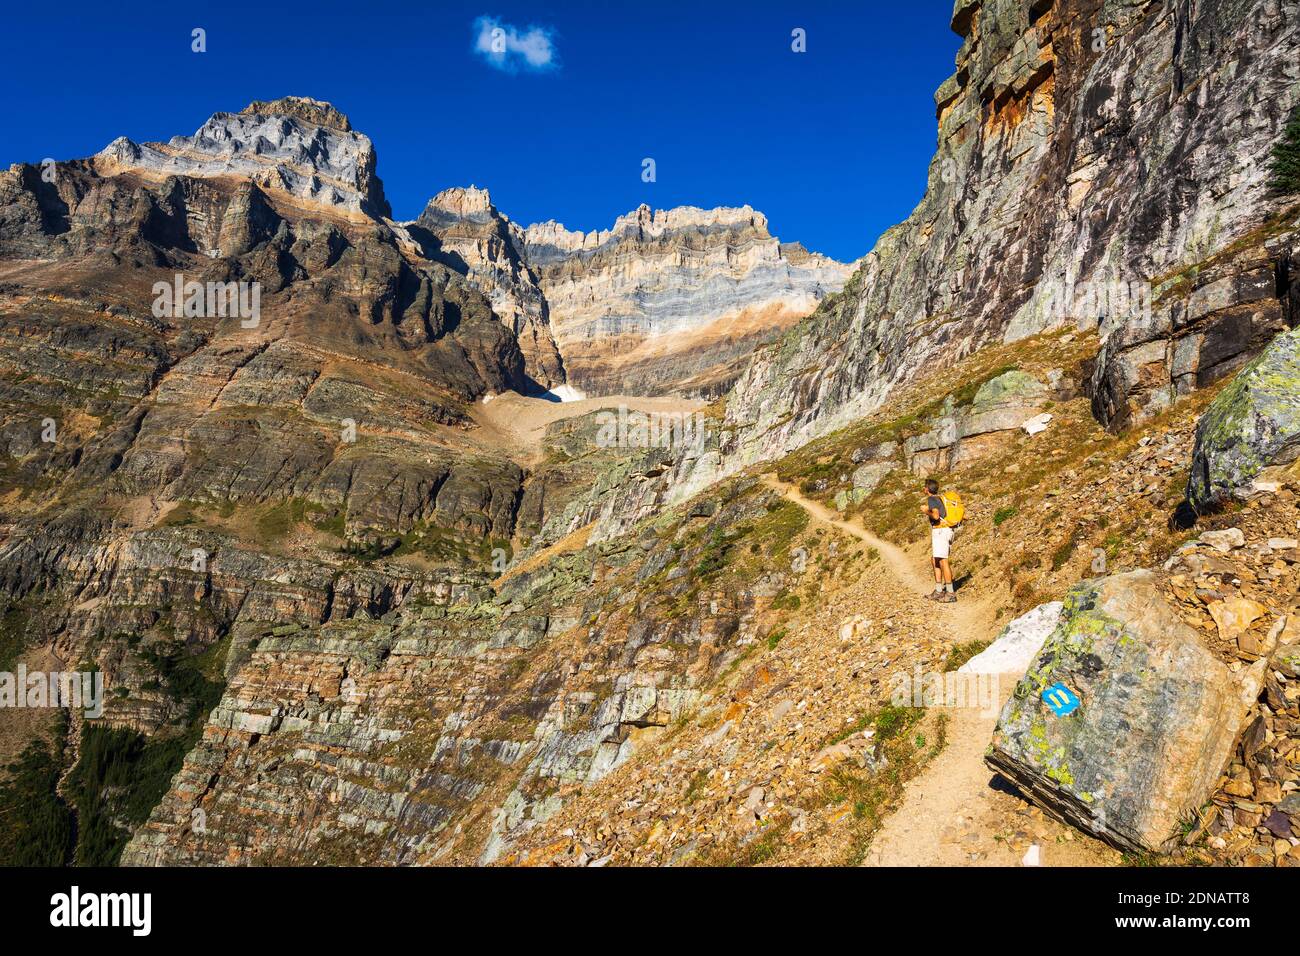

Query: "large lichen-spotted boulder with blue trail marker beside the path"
(985, 571), (1264, 851)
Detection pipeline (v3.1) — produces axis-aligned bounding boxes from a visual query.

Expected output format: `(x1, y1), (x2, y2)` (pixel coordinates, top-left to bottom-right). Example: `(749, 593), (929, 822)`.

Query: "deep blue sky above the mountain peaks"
(0, 0), (959, 259)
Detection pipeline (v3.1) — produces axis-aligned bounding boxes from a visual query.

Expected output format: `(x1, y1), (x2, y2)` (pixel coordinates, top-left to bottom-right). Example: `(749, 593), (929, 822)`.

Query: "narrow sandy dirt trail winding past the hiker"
(763, 475), (1100, 866)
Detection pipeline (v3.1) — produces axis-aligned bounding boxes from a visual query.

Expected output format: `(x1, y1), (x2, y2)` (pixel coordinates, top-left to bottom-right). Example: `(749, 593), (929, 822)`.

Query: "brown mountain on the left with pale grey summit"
(0, 99), (592, 862)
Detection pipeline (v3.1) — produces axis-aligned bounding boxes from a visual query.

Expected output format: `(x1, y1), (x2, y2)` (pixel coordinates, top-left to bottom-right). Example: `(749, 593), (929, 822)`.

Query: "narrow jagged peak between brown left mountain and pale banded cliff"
(408, 186), (564, 390)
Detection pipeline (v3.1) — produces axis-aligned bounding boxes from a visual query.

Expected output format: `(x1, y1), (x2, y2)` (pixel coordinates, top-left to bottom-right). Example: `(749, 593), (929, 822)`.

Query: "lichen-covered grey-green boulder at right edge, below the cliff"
(1187, 329), (1300, 511)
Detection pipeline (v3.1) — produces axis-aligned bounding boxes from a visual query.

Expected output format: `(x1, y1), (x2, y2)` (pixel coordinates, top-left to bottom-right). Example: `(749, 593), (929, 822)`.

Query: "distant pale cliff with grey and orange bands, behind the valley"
(524, 206), (852, 398)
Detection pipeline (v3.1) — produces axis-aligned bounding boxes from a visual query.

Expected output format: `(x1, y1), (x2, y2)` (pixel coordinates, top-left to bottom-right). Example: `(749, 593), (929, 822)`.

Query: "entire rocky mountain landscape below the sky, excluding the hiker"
(0, 0), (1300, 866)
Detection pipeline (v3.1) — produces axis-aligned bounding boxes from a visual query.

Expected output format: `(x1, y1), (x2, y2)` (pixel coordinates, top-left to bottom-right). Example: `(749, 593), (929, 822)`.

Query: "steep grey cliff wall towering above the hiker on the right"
(587, 0), (1300, 533)
